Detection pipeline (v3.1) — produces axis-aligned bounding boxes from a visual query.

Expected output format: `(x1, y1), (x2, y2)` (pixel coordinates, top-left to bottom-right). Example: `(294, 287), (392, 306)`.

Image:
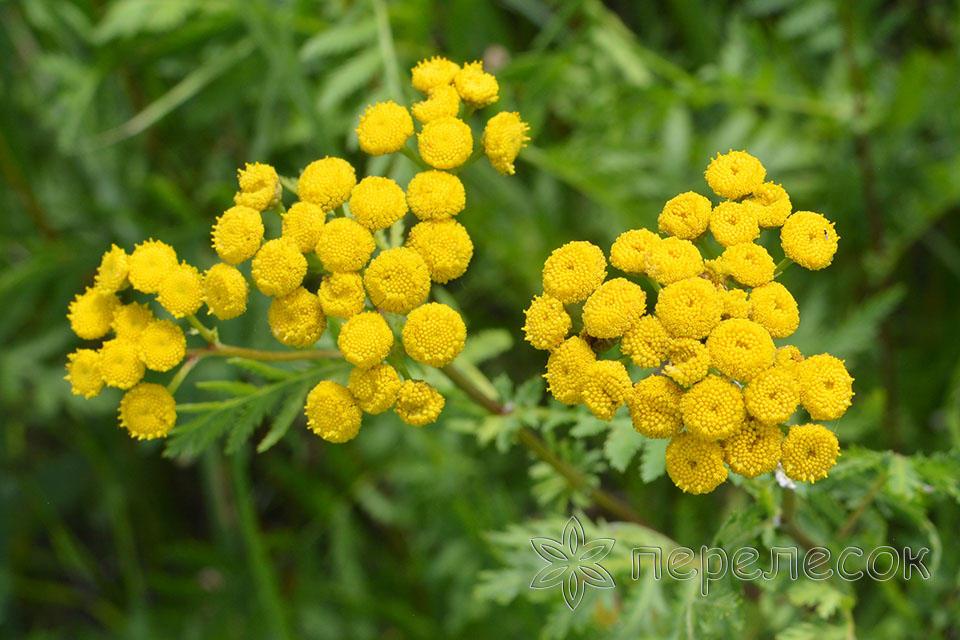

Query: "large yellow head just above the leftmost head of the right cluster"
(543, 241), (607, 304)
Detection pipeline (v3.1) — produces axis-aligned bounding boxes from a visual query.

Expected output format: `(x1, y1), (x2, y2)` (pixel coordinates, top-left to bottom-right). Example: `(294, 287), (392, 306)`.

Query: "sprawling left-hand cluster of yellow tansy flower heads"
(66, 57), (529, 442)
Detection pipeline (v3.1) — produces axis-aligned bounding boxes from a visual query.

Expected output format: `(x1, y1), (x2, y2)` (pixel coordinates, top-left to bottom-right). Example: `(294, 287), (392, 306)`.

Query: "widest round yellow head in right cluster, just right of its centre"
(656, 278), (723, 340)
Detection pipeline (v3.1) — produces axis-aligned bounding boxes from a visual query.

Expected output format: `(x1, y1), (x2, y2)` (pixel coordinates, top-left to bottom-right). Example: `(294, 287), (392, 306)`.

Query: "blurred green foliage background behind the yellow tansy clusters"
(0, 0), (960, 640)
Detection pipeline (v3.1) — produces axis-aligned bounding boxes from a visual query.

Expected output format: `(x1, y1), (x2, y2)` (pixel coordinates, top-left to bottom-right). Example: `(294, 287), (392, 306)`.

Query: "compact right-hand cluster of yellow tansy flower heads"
(524, 151), (853, 493)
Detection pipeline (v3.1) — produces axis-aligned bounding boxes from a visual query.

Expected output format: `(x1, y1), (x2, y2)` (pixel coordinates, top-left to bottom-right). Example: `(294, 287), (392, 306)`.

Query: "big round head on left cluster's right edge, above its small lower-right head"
(401, 302), (467, 368)
